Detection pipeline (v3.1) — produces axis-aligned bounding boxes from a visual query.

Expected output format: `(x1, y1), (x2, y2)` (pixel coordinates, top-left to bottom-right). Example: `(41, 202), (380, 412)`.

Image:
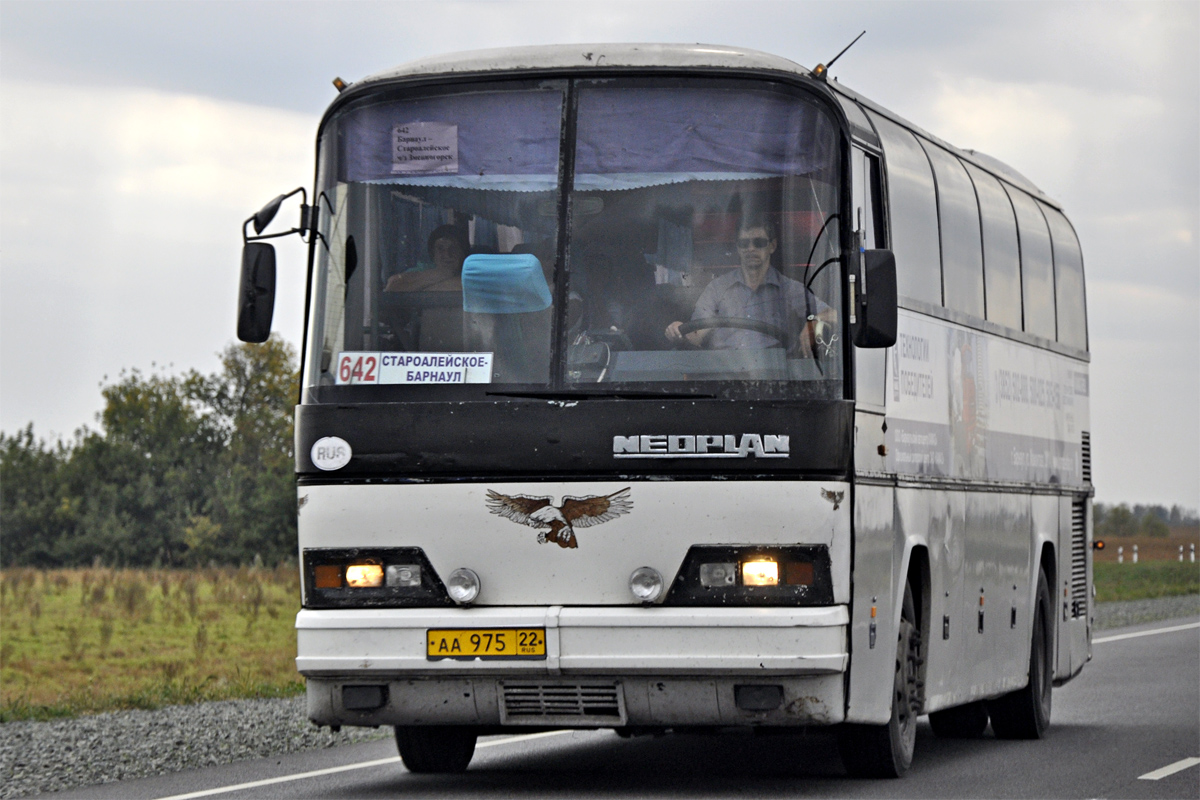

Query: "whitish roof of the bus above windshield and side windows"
(354, 43), (1062, 210)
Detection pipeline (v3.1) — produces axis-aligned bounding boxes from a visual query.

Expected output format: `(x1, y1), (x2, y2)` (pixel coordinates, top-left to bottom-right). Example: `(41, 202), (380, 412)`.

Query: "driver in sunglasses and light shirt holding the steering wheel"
(665, 217), (836, 355)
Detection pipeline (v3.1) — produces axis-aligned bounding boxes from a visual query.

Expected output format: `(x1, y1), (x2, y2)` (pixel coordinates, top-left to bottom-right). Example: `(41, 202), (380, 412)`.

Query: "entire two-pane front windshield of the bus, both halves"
(306, 79), (845, 399)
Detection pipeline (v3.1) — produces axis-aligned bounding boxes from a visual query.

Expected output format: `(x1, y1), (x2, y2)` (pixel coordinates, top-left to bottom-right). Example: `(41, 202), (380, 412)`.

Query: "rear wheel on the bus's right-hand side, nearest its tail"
(988, 570), (1054, 739)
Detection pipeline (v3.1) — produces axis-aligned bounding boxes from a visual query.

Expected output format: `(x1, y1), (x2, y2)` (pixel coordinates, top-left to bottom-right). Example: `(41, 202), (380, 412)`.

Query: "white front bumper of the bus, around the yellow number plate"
(296, 606), (850, 727)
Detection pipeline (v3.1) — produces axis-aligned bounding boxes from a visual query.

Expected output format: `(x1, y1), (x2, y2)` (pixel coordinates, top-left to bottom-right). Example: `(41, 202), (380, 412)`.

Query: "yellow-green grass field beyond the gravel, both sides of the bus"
(0, 556), (1200, 722)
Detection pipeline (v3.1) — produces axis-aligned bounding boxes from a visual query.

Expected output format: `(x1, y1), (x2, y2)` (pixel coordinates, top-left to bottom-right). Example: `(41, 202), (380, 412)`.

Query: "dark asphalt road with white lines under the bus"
(42, 618), (1200, 800)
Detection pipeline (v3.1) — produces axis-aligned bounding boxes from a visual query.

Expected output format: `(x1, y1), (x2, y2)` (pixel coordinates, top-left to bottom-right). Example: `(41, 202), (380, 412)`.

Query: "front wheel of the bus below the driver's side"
(838, 585), (920, 777)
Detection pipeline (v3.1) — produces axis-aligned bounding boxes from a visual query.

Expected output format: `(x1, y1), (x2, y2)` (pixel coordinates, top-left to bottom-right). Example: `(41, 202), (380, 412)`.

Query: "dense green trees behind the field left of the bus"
(0, 336), (299, 567)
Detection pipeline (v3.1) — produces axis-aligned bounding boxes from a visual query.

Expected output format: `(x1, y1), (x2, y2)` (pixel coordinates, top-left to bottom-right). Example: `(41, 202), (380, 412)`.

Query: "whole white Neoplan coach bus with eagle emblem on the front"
(239, 44), (1092, 776)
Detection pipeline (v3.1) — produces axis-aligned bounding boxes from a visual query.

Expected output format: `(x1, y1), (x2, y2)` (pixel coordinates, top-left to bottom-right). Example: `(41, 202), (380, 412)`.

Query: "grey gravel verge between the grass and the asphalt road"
(0, 595), (1200, 800)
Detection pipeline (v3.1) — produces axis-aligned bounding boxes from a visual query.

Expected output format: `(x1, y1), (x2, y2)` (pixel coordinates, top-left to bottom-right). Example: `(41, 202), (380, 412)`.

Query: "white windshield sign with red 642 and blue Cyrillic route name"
(336, 353), (492, 386)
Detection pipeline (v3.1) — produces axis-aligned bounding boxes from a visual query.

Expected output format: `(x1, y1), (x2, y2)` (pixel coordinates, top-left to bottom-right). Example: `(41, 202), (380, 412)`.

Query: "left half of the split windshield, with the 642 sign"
(308, 83), (564, 393)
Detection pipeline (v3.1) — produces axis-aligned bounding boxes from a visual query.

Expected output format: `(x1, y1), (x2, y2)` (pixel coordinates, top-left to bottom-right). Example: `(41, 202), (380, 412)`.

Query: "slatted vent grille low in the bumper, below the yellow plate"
(502, 681), (625, 726)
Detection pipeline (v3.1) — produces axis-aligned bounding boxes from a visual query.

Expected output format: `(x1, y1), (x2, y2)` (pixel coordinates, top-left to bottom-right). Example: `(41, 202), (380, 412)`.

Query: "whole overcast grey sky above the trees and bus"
(0, 0), (1200, 507)
